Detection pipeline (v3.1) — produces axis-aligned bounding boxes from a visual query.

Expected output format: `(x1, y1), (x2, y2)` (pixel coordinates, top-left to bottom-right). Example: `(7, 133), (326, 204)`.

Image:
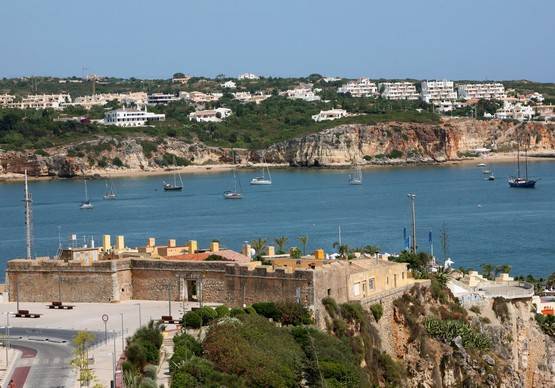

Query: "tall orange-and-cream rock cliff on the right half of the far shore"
(262, 119), (555, 166)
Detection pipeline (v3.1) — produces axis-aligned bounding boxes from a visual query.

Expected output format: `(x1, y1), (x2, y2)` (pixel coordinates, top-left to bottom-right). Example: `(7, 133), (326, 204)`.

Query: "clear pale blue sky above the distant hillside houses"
(0, 0), (555, 82)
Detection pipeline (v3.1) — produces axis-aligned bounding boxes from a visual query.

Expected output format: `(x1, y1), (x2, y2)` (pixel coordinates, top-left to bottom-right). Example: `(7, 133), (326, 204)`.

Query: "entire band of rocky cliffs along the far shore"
(0, 119), (555, 177)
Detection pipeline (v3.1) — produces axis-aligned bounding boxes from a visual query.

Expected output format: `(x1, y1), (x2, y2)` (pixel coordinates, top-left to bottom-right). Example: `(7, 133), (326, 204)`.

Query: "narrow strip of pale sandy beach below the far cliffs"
(0, 152), (555, 183)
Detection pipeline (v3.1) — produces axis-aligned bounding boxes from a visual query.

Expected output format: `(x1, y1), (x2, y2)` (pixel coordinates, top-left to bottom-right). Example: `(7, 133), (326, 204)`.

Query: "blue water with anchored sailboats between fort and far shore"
(0, 161), (555, 277)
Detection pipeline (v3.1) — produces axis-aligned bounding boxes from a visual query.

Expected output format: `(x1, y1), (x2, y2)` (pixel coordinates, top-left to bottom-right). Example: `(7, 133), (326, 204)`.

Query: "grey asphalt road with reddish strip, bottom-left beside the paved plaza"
(4, 328), (104, 388)
